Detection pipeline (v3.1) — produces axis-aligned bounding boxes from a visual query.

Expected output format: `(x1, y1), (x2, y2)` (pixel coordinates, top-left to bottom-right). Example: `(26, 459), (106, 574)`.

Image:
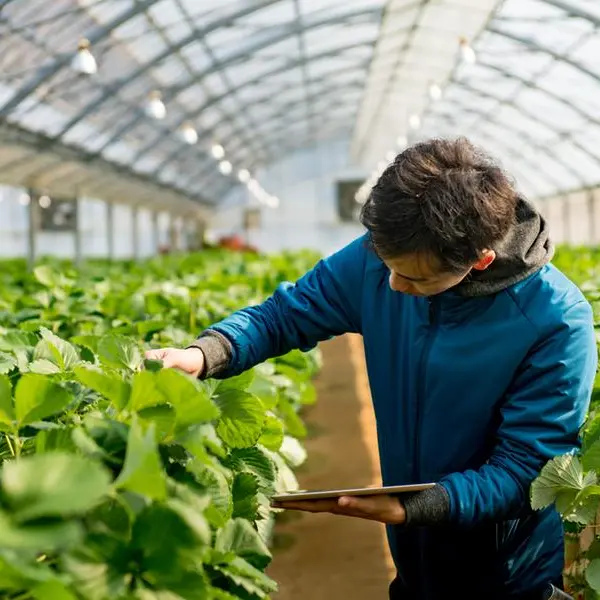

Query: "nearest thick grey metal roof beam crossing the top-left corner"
(0, 0), (157, 117)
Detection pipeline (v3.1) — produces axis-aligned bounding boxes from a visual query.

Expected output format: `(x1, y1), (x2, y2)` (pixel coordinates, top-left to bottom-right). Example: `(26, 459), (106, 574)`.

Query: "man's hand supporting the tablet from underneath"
(272, 496), (406, 525)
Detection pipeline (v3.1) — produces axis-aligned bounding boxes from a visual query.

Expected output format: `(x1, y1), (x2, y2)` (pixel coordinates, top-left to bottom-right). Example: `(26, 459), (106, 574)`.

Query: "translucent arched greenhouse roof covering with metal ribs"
(0, 0), (600, 208)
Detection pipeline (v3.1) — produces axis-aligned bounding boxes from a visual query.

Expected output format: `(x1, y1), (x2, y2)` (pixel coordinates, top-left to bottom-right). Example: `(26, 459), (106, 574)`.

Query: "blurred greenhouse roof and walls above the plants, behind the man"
(0, 0), (600, 260)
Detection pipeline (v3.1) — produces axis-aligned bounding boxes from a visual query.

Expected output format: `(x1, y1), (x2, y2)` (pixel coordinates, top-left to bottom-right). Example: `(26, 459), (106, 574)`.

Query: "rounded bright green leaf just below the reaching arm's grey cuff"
(216, 390), (266, 448)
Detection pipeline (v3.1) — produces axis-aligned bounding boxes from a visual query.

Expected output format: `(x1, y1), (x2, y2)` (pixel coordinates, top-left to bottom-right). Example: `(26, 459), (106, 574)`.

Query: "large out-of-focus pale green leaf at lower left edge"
(2, 452), (110, 521)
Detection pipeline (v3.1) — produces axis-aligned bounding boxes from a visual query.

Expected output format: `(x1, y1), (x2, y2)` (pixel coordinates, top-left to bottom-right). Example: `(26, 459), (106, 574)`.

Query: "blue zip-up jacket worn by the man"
(205, 229), (597, 600)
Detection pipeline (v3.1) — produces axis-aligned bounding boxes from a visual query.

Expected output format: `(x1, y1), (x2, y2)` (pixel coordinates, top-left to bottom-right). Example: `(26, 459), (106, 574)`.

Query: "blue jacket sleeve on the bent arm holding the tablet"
(441, 301), (598, 526)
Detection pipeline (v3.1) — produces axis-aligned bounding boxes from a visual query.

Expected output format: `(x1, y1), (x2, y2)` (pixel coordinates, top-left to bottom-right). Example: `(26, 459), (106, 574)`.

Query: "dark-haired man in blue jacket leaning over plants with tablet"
(149, 139), (597, 600)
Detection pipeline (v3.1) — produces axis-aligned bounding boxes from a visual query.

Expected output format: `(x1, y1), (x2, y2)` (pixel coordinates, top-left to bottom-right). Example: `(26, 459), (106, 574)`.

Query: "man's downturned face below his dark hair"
(384, 254), (474, 296)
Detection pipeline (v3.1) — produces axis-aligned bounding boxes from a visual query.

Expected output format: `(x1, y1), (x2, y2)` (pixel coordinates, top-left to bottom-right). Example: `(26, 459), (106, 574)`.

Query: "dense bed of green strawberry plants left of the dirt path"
(0, 253), (319, 600)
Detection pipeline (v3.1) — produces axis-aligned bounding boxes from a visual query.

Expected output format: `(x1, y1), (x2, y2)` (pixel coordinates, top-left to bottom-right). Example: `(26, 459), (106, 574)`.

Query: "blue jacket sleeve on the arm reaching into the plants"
(204, 237), (368, 378)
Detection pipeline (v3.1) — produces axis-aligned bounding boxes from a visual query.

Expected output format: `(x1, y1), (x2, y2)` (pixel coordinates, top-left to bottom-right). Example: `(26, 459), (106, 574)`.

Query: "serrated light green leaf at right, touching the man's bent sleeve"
(531, 454), (596, 510)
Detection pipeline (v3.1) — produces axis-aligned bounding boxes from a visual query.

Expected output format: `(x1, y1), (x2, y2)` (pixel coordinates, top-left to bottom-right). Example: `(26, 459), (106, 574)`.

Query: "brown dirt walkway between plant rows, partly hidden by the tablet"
(269, 336), (392, 600)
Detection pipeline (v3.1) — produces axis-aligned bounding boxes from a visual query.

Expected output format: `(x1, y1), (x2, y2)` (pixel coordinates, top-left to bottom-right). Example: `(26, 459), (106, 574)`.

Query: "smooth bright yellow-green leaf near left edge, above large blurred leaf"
(15, 373), (72, 426)
